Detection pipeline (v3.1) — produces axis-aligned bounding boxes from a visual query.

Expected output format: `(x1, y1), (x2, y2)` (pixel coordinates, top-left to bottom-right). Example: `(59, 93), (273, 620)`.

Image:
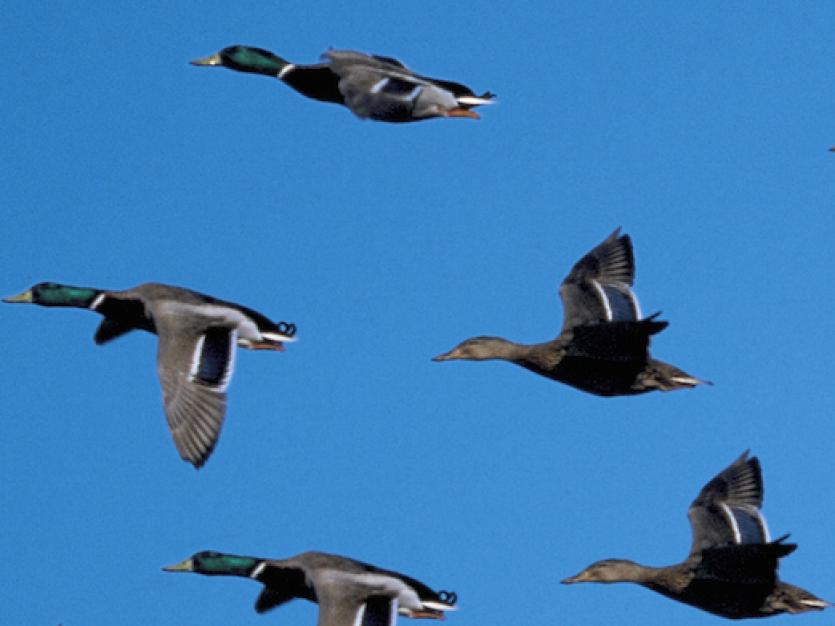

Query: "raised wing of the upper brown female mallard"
(560, 228), (641, 332)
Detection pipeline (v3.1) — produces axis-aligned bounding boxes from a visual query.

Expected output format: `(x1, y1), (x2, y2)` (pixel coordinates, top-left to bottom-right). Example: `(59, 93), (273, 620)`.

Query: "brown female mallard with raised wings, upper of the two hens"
(433, 228), (710, 396)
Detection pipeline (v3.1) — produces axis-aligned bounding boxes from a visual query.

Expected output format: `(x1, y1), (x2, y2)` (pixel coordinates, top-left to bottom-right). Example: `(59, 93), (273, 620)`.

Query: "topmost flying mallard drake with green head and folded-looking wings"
(191, 45), (495, 122)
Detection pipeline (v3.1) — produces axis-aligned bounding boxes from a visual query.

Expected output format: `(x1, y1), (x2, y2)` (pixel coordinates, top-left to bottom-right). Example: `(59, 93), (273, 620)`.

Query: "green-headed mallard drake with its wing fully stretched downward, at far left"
(3, 283), (296, 467)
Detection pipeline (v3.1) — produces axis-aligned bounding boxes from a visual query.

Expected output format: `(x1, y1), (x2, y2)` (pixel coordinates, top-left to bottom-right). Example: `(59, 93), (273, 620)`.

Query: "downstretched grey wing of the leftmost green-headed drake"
(156, 317), (237, 467)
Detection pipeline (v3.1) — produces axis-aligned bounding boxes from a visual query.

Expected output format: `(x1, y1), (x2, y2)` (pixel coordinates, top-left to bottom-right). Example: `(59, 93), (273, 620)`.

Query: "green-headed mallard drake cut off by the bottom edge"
(163, 551), (457, 626)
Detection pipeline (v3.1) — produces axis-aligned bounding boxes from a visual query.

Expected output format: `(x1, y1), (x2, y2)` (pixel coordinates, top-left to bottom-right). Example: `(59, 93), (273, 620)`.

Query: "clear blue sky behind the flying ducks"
(0, 0), (835, 626)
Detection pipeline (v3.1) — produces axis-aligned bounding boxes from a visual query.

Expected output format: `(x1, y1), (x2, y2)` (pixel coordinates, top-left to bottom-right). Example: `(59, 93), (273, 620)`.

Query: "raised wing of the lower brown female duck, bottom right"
(687, 451), (770, 555)
